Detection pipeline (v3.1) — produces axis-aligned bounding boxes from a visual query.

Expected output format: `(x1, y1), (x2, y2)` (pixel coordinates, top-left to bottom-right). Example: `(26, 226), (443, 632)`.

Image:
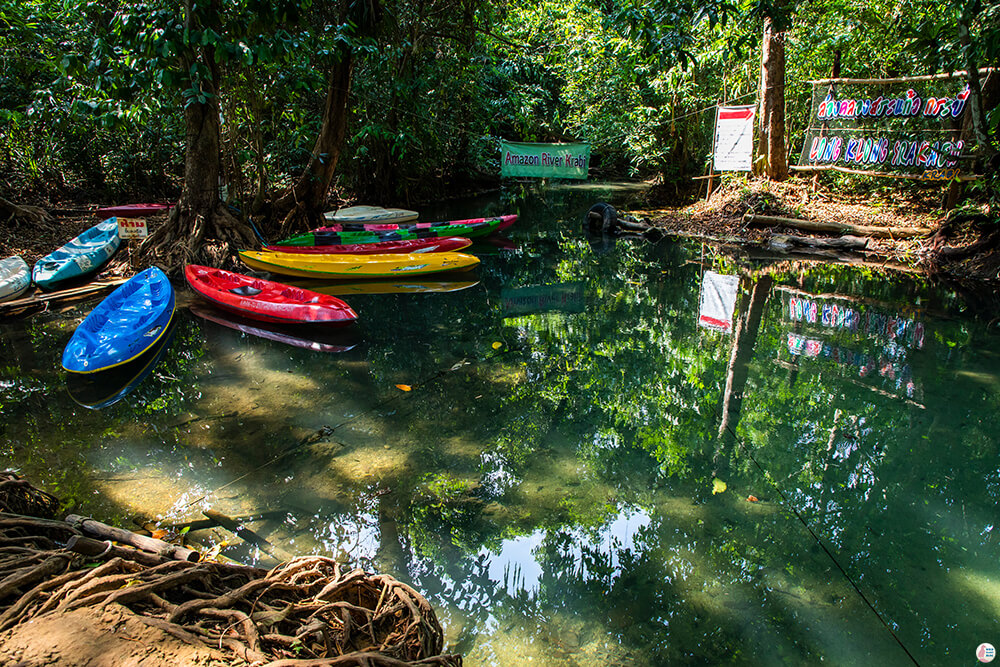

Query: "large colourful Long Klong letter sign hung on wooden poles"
(799, 77), (969, 180)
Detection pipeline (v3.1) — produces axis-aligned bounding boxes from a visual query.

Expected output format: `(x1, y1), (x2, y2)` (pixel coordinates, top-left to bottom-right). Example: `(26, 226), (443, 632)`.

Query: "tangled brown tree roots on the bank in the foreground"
(0, 474), (462, 667)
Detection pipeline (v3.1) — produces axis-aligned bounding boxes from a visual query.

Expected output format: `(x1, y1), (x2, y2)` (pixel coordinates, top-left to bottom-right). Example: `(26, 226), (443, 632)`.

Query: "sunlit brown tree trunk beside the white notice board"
(758, 17), (788, 181)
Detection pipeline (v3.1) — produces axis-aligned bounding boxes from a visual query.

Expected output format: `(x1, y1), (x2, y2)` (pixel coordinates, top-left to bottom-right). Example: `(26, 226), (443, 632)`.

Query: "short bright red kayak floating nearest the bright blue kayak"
(184, 264), (358, 324)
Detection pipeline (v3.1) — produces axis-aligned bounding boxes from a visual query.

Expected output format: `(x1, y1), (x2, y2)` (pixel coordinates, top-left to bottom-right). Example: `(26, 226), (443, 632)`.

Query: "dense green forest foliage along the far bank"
(0, 0), (1000, 207)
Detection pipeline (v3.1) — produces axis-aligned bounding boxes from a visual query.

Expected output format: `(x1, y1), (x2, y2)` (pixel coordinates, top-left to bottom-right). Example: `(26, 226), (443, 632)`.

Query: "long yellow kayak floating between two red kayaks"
(240, 250), (479, 278)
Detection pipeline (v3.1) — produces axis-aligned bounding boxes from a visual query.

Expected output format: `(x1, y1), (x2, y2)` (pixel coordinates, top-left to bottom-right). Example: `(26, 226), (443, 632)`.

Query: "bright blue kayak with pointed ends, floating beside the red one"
(62, 266), (174, 373)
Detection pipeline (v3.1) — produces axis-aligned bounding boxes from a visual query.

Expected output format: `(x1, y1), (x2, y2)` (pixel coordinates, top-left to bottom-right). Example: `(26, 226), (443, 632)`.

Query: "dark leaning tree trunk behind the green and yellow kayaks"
(274, 48), (354, 236)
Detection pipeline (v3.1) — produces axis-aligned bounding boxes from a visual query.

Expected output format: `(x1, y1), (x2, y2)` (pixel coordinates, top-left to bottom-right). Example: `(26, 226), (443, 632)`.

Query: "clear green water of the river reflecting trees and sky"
(0, 185), (1000, 666)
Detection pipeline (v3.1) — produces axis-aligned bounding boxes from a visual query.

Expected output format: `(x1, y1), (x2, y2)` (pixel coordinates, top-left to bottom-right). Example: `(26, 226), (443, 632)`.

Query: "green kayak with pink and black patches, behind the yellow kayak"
(275, 215), (517, 246)
